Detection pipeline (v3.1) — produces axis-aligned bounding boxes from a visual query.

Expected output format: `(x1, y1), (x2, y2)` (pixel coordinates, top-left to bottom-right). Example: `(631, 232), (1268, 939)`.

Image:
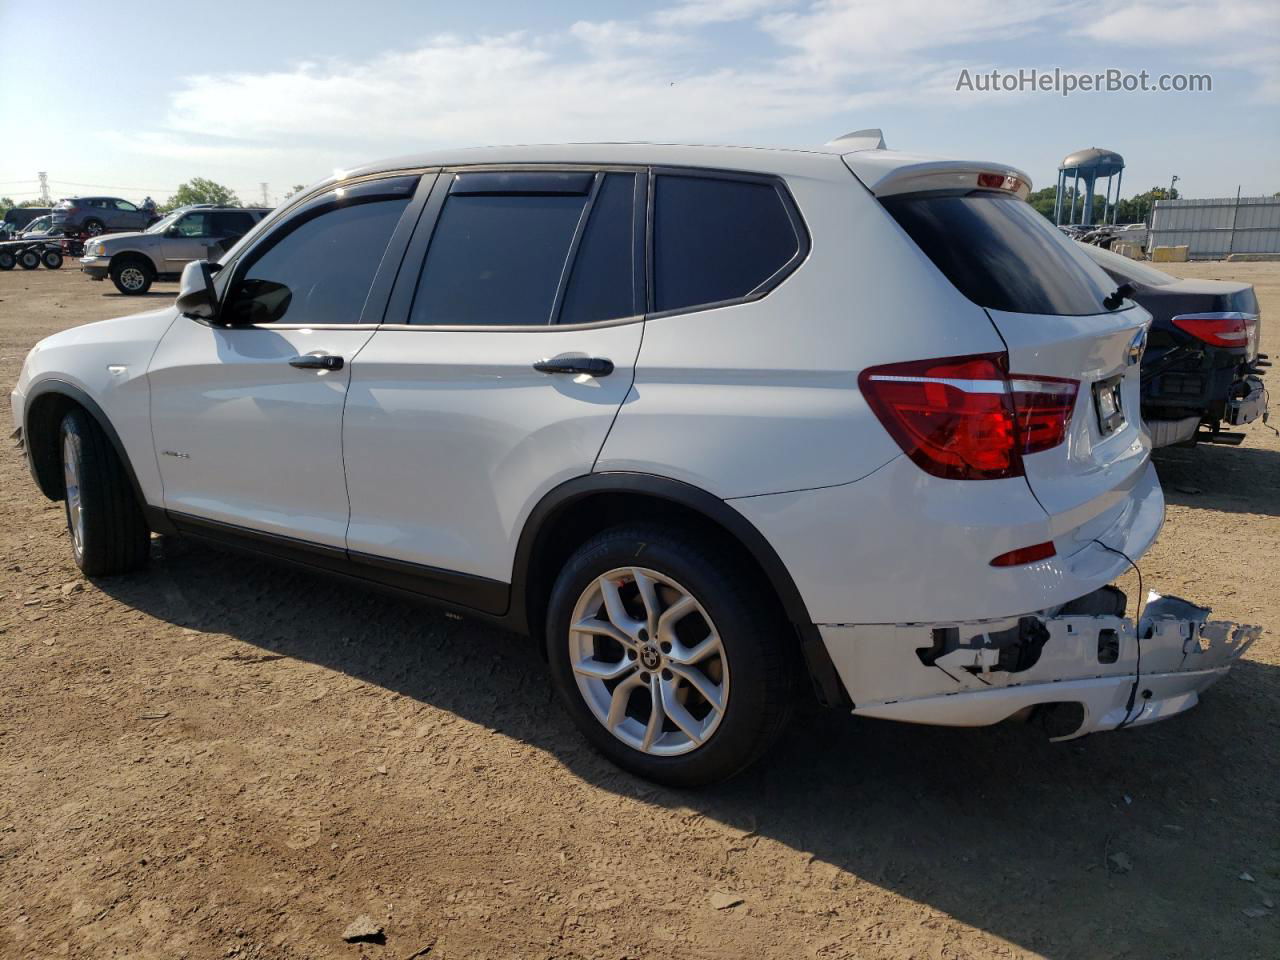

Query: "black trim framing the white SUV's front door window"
(204, 175), (439, 330)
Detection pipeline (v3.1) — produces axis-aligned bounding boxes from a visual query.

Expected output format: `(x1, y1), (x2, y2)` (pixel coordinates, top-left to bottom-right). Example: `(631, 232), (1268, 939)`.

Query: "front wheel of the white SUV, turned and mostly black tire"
(58, 407), (151, 577)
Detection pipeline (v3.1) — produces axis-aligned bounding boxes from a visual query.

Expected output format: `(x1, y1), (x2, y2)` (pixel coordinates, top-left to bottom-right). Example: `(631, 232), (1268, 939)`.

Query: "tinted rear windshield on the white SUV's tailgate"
(881, 191), (1115, 316)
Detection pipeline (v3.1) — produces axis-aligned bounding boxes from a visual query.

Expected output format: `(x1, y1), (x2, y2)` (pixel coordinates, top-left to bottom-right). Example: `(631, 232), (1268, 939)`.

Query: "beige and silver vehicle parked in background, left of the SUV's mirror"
(79, 206), (269, 296)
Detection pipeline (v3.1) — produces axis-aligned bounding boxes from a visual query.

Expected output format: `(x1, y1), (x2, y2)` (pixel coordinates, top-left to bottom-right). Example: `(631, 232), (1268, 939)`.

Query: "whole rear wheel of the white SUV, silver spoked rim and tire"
(547, 524), (792, 787)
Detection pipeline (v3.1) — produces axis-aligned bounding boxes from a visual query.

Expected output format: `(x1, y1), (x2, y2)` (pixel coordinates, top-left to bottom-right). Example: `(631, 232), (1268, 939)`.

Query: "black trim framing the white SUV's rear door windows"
(379, 161), (649, 333)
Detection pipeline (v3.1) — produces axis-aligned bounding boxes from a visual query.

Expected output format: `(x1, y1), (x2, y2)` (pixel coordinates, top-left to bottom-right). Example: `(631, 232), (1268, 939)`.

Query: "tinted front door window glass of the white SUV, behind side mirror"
(223, 197), (408, 324)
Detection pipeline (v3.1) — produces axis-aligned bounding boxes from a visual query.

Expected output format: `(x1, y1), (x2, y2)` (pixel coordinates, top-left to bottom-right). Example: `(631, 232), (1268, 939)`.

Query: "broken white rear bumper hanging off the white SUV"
(819, 591), (1261, 740)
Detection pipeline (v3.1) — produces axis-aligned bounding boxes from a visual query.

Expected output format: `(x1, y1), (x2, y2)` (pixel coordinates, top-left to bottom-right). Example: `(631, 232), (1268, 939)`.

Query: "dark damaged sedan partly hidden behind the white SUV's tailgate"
(1082, 244), (1270, 447)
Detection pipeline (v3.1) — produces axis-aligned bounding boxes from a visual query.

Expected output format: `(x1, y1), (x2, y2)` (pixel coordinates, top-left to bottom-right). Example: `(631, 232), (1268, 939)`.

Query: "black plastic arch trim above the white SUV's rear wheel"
(508, 472), (849, 705)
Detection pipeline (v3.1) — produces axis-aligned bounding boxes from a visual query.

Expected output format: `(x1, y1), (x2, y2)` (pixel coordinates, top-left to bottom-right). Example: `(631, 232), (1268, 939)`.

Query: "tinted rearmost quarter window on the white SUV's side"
(653, 174), (801, 312)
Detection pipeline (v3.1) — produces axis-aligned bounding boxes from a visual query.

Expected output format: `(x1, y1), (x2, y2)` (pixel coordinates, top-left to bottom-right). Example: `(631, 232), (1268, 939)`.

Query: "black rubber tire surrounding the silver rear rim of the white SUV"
(547, 524), (795, 787)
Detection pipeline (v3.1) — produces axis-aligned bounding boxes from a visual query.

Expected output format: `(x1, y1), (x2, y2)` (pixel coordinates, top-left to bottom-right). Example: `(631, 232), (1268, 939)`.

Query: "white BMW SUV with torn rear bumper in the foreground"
(13, 132), (1257, 785)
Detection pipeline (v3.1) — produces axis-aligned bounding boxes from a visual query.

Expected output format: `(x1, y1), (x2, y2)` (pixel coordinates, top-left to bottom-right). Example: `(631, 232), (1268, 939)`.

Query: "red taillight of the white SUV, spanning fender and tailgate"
(858, 353), (1079, 480)
